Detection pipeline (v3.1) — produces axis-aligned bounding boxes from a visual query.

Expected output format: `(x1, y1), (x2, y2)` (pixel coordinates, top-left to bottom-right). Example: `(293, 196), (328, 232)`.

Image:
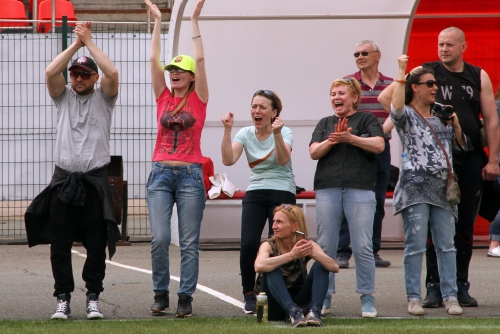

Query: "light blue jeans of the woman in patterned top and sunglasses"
(401, 203), (457, 300)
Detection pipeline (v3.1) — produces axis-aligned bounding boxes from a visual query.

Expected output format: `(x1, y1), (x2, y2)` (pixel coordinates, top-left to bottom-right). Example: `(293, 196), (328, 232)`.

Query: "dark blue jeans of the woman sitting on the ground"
(261, 262), (328, 321)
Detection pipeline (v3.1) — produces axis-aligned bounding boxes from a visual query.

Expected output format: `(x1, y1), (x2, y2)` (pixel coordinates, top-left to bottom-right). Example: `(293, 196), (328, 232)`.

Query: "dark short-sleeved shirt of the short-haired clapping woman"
(309, 111), (383, 191)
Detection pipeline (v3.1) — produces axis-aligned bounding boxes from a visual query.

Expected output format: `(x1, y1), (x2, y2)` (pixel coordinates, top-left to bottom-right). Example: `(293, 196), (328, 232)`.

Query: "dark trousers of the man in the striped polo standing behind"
(337, 140), (391, 258)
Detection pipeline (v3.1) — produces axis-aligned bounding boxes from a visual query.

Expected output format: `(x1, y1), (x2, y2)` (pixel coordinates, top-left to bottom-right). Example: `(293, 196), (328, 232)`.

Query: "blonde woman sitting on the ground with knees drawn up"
(255, 204), (339, 327)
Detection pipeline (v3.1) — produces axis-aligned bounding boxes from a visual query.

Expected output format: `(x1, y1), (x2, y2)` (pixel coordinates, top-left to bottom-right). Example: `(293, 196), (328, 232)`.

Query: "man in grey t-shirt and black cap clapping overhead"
(25, 22), (119, 319)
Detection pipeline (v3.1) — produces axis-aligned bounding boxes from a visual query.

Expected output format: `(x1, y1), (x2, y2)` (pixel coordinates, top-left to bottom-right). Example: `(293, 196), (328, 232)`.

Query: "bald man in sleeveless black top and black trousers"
(422, 27), (500, 307)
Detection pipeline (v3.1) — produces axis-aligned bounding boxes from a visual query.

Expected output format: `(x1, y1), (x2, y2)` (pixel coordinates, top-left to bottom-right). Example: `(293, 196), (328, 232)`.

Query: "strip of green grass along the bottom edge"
(0, 317), (500, 334)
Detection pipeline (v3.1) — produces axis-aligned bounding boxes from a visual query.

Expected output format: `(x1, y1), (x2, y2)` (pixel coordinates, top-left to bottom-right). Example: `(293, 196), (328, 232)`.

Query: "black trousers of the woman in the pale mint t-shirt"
(240, 190), (296, 293)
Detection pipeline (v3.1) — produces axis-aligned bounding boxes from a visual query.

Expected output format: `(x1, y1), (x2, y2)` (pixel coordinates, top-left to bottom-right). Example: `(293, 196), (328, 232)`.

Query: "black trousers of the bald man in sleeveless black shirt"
(425, 151), (484, 283)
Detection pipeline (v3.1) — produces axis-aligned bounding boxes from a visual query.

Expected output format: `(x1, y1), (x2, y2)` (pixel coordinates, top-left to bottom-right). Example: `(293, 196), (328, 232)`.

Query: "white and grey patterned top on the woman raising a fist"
(391, 105), (458, 218)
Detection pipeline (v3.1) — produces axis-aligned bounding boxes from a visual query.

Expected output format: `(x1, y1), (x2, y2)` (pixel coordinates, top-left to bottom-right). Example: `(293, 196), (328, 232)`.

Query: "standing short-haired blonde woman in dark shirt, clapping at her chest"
(309, 78), (385, 317)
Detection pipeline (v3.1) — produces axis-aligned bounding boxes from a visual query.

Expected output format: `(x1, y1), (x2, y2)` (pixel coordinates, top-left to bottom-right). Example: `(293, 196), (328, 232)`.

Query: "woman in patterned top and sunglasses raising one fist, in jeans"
(391, 55), (464, 315)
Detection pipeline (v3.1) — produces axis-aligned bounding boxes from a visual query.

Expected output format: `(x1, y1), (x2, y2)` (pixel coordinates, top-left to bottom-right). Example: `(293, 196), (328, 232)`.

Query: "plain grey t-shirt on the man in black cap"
(52, 86), (118, 172)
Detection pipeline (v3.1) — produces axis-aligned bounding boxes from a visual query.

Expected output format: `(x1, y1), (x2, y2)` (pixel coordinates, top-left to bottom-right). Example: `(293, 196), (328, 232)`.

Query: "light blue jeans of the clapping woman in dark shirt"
(316, 187), (375, 294)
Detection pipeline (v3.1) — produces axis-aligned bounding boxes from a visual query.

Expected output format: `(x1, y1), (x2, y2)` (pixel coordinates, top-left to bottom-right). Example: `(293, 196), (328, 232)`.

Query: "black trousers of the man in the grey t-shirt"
(49, 180), (107, 297)
